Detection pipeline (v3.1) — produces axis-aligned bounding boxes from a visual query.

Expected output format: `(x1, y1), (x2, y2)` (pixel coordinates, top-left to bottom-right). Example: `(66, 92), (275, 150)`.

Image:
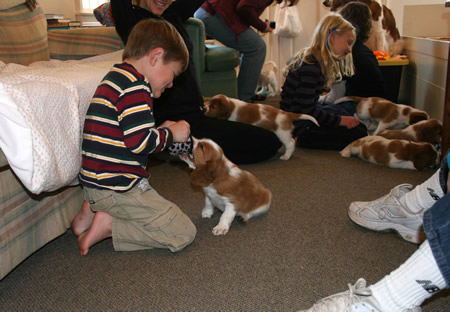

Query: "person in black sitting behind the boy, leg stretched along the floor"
(111, 0), (281, 164)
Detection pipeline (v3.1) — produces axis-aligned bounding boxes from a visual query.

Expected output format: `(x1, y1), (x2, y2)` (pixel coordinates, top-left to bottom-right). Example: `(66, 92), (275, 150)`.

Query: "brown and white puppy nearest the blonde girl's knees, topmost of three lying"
(335, 96), (428, 135)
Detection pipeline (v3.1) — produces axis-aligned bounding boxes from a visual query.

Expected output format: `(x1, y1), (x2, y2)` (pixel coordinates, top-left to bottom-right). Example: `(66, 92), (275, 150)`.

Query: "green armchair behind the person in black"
(185, 18), (240, 98)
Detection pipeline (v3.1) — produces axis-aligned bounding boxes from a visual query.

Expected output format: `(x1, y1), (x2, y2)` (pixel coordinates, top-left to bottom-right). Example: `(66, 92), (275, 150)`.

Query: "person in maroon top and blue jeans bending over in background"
(194, 0), (298, 102)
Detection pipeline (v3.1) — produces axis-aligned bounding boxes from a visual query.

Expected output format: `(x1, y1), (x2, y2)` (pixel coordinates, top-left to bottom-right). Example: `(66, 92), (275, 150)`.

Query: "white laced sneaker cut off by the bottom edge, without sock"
(300, 278), (422, 312)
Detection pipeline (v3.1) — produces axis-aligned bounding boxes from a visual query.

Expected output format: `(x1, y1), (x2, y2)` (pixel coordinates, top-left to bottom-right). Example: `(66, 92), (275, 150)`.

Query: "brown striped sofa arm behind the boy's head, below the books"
(48, 27), (123, 60)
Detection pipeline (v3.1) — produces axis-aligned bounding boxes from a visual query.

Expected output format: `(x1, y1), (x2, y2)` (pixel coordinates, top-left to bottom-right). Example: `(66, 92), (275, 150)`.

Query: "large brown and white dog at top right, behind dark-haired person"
(323, 0), (404, 57)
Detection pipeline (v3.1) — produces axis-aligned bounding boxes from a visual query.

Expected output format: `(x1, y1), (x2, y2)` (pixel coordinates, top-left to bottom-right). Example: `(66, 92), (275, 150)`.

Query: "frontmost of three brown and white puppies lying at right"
(341, 136), (439, 170)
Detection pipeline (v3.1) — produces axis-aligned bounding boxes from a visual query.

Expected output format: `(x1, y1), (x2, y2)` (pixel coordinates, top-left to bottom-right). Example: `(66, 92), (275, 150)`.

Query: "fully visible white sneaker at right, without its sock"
(348, 184), (425, 244)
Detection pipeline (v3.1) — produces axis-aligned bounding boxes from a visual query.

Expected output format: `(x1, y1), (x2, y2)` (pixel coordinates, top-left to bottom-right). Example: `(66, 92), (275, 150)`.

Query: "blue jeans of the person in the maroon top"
(194, 8), (266, 102)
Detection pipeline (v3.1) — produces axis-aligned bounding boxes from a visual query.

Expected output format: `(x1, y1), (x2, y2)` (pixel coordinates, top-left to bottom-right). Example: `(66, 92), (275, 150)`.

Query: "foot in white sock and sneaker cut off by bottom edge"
(298, 241), (448, 312)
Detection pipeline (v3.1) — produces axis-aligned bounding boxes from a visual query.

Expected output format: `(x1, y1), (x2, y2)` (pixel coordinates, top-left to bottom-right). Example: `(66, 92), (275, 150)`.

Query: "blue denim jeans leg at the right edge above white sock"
(423, 194), (450, 288)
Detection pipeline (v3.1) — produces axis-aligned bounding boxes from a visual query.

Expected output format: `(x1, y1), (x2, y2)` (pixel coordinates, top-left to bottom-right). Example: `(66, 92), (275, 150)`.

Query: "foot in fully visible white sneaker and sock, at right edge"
(348, 151), (448, 244)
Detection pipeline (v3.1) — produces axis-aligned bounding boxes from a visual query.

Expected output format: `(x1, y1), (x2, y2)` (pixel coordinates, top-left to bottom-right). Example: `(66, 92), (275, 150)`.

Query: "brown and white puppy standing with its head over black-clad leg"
(204, 94), (319, 160)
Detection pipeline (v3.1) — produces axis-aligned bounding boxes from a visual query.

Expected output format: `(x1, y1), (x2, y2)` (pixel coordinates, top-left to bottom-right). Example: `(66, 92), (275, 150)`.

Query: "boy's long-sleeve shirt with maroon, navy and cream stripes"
(79, 63), (172, 192)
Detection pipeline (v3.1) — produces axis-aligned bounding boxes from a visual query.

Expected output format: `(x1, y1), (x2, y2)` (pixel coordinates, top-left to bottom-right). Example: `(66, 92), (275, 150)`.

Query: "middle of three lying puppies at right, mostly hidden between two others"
(378, 119), (442, 145)
